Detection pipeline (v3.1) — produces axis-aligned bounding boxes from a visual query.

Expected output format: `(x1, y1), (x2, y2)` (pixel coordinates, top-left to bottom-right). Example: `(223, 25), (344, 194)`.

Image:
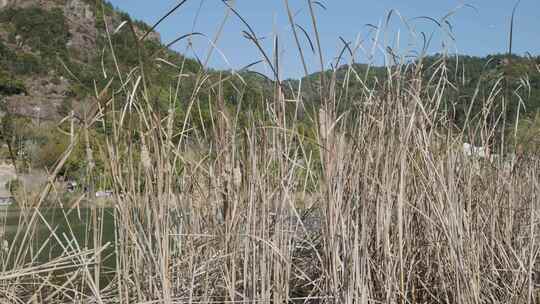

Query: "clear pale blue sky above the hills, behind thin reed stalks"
(110, 0), (540, 78)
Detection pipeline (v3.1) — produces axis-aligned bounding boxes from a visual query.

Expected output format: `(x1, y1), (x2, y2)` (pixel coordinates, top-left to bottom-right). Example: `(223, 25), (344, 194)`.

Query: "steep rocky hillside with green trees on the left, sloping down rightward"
(0, 0), (271, 175)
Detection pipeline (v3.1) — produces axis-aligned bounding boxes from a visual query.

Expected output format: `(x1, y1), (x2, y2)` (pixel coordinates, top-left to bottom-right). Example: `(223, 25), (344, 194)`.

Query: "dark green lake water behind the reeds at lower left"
(0, 206), (115, 271)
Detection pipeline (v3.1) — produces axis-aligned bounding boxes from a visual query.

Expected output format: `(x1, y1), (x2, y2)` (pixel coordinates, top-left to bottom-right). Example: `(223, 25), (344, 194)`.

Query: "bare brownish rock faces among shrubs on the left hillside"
(0, 0), (160, 120)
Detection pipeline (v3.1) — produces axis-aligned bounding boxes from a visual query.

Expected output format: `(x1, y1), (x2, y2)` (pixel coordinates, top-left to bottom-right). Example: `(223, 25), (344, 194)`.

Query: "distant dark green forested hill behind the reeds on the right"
(298, 54), (540, 152)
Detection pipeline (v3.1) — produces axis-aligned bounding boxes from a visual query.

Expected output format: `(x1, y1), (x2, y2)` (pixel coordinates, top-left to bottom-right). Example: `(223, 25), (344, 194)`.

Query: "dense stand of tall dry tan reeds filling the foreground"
(0, 1), (540, 303)
